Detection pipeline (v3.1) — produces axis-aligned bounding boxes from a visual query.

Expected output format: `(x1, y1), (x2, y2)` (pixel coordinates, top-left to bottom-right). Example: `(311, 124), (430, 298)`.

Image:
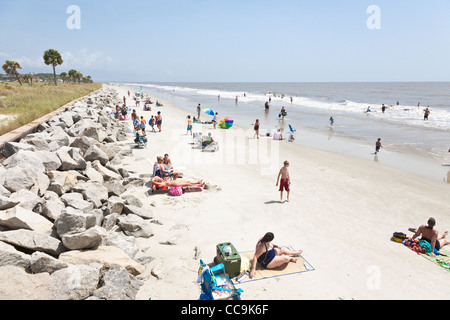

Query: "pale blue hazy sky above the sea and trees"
(0, 0), (450, 82)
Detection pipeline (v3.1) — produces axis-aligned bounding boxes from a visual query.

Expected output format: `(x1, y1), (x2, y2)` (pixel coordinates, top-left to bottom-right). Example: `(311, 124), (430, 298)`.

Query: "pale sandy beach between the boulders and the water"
(103, 85), (450, 300)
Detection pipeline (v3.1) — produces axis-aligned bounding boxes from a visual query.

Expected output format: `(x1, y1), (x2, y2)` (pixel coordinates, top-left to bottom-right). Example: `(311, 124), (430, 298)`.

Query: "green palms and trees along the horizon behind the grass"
(2, 49), (93, 86)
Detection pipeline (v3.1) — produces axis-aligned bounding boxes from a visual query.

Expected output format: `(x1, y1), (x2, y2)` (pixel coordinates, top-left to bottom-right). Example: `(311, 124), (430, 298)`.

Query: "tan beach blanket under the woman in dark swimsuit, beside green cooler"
(239, 246), (315, 283)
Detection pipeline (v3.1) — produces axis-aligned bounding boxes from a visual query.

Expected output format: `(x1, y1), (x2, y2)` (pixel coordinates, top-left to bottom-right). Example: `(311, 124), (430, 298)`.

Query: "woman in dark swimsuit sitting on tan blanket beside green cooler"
(250, 232), (303, 278)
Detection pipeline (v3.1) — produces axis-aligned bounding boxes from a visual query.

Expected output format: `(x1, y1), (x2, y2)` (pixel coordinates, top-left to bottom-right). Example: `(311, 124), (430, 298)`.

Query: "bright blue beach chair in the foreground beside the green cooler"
(197, 260), (244, 300)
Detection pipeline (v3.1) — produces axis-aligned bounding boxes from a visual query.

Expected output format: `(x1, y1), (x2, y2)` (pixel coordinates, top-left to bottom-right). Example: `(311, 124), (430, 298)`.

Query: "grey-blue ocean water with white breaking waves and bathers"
(121, 82), (450, 181)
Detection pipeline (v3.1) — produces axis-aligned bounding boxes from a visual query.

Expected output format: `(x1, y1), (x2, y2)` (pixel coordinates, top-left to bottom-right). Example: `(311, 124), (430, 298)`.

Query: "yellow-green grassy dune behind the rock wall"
(0, 83), (102, 135)
